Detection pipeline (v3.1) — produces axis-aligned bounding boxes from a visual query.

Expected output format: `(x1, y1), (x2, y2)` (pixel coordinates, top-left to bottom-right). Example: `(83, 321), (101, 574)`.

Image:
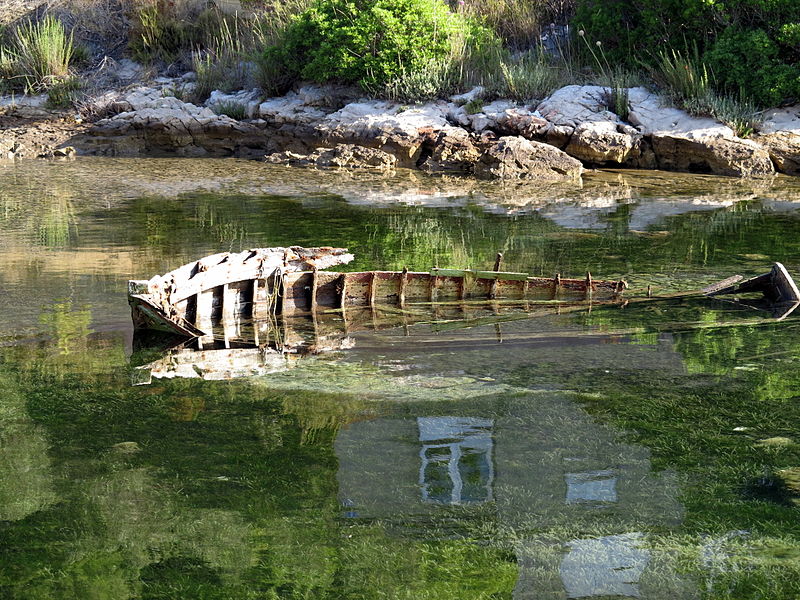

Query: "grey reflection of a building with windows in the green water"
(335, 392), (691, 600)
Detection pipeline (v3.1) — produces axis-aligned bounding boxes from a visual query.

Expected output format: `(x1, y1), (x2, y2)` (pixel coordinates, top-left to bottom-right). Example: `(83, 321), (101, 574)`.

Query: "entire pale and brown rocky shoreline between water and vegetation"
(0, 74), (800, 181)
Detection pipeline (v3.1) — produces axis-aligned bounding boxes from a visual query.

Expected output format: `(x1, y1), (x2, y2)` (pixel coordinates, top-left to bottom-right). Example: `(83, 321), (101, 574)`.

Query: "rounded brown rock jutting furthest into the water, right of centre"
(475, 136), (583, 181)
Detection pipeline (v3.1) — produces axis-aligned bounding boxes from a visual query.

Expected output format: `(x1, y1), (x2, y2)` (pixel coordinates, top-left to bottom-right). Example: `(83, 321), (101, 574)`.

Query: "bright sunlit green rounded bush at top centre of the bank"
(265, 0), (499, 91)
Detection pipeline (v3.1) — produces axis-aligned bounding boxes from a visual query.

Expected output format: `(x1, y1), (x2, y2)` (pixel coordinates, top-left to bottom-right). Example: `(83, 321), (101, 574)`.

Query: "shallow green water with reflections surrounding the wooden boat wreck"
(0, 159), (800, 600)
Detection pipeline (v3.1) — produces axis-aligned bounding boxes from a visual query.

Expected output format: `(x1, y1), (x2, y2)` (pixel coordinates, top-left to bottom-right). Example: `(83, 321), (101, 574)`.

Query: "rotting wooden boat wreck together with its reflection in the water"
(129, 247), (800, 385)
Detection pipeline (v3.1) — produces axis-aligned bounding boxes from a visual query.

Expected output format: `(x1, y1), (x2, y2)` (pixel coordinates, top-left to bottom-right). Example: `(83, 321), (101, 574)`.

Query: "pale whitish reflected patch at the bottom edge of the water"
(559, 532), (650, 598)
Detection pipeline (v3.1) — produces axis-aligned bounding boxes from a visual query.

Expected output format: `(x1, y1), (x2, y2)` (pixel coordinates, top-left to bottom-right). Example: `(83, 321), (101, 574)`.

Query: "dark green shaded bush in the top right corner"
(573, 0), (800, 106)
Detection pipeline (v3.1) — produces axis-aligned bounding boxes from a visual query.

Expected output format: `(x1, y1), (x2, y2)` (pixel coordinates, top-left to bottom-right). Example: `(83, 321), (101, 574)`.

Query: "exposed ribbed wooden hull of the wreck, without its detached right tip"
(128, 246), (627, 338)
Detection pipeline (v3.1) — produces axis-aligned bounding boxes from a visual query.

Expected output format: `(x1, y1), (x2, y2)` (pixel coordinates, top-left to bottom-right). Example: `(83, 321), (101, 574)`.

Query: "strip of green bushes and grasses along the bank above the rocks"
(0, 0), (800, 135)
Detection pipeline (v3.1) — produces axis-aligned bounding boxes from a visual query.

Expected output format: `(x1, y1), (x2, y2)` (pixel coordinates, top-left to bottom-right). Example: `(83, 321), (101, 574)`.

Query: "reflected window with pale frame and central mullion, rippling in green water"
(417, 417), (494, 504)
